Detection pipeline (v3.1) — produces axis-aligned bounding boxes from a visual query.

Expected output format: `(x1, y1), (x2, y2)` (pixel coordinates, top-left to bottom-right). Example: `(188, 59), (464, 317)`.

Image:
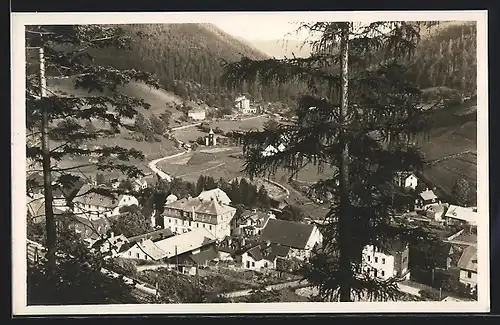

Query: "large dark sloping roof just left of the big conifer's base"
(260, 219), (315, 249)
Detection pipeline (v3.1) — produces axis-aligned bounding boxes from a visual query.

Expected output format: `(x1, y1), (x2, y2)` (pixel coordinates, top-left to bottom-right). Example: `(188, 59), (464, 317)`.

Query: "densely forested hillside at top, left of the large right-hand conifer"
(90, 24), (306, 106)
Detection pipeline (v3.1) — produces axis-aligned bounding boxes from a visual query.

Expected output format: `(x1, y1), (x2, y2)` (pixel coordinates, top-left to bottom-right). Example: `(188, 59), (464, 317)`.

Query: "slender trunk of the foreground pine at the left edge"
(39, 46), (56, 265)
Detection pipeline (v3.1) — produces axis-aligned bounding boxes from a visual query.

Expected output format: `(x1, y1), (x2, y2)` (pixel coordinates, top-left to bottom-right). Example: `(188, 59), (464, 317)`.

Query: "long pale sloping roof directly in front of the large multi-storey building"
(155, 228), (215, 258)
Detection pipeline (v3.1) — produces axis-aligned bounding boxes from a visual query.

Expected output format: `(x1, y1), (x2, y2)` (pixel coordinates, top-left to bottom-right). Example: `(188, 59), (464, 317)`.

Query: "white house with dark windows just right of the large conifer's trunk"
(362, 241), (410, 280)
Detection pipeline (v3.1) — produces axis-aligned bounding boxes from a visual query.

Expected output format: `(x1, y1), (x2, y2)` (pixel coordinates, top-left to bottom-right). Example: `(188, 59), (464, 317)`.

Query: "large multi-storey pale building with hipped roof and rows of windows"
(163, 190), (236, 240)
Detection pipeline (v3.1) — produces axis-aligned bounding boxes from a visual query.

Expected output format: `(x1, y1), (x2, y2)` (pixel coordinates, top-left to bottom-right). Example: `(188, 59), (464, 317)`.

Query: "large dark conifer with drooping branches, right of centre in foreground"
(224, 22), (433, 301)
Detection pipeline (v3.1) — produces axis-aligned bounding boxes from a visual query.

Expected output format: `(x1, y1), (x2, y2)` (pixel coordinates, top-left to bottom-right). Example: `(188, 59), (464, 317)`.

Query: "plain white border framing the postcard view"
(11, 10), (490, 315)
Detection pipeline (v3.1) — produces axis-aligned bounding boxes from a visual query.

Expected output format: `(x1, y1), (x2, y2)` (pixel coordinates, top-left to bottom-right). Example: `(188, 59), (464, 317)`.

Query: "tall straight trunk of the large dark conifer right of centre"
(338, 22), (352, 302)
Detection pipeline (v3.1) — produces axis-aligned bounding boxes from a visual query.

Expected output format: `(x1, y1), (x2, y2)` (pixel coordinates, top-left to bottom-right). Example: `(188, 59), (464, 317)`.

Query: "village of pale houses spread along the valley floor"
(27, 92), (477, 301)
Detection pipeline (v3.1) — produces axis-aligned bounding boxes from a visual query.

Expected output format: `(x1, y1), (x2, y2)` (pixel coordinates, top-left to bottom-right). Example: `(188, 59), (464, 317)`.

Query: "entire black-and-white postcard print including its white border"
(11, 11), (490, 315)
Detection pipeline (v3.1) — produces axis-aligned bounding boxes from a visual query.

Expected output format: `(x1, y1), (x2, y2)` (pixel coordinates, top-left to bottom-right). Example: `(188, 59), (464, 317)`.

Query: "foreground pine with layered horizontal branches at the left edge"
(25, 25), (158, 264)
